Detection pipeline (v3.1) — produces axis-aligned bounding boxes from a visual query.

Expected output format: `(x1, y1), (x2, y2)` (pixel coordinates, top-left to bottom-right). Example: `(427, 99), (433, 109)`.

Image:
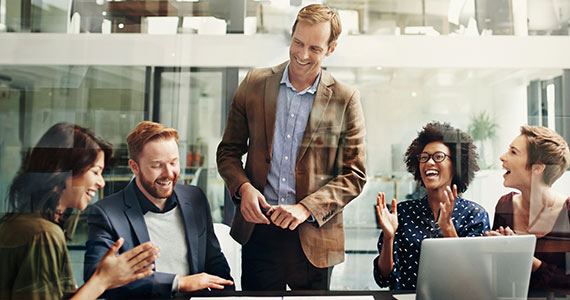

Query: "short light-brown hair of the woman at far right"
(521, 126), (570, 185)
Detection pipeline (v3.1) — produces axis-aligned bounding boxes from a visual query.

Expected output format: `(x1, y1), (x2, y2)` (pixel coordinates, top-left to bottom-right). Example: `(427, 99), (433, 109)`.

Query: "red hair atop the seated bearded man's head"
(127, 121), (178, 161)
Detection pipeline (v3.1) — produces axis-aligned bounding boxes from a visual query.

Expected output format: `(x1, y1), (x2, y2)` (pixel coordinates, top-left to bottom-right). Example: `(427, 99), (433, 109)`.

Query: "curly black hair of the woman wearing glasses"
(404, 122), (479, 193)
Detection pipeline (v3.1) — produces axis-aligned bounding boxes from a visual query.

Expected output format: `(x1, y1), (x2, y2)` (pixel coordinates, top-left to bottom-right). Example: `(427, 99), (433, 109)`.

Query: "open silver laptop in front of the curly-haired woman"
(416, 235), (536, 300)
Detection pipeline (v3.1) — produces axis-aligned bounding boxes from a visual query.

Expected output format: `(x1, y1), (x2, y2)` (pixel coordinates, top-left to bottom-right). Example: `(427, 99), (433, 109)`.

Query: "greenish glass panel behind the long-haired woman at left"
(0, 65), (148, 211)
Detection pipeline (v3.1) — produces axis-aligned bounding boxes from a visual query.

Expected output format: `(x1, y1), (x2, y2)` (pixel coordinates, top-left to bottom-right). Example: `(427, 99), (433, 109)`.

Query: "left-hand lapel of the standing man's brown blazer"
(262, 62), (287, 157)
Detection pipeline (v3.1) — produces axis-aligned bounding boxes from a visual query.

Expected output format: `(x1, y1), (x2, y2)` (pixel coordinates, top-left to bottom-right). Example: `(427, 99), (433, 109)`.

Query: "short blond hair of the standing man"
(291, 4), (342, 47)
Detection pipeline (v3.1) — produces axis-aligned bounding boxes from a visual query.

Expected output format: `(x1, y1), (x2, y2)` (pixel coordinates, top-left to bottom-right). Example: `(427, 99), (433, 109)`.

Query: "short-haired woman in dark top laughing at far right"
(487, 126), (570, 289)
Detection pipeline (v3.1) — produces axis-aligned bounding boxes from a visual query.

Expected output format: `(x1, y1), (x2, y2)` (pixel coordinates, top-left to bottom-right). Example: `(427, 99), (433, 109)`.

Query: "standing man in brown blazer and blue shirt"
(217, 4), (366, 290)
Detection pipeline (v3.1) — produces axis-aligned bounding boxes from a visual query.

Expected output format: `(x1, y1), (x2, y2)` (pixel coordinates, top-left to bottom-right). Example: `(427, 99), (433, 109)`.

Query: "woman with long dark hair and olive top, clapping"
(0, 123), (158, 299)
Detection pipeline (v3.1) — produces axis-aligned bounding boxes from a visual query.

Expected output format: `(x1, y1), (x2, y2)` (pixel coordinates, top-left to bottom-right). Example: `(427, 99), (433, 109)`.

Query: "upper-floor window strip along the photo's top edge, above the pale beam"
(4, 0), (570, 36)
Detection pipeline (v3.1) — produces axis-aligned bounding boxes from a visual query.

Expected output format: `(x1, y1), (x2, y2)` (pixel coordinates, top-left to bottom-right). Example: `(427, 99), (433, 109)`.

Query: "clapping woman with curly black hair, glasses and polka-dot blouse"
(374, 122), (489, 290)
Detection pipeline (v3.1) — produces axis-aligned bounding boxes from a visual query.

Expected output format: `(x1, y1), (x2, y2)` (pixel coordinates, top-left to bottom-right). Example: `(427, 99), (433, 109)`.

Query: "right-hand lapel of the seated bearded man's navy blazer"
(174, 185), (199, 274)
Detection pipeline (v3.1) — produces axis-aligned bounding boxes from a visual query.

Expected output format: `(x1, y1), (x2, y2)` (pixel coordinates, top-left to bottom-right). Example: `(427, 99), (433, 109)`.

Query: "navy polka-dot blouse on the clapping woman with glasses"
(374, 196), (489, 290)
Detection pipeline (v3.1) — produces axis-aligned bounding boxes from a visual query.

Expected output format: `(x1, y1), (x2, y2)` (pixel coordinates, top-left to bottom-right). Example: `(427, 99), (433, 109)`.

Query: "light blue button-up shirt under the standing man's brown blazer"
(263, 64), (321, 205)
